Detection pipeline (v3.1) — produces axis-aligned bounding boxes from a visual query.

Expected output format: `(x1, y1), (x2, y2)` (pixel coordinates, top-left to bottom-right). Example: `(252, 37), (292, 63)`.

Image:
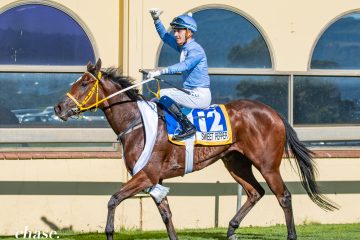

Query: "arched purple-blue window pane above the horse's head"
(0, 4), (95, 66)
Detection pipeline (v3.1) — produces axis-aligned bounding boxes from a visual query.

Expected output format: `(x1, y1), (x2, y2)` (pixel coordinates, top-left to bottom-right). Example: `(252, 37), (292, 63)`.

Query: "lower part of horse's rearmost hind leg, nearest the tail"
(261, 169), (297, 240)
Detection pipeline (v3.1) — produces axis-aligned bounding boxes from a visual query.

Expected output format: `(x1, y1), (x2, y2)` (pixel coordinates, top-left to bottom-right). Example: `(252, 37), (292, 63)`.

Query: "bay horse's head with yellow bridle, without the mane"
(54, 59), (104, 121)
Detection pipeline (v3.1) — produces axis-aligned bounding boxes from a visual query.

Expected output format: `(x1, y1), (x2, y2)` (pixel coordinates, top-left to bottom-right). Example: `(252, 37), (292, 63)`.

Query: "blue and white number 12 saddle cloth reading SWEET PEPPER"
(164, 105), (232, 146)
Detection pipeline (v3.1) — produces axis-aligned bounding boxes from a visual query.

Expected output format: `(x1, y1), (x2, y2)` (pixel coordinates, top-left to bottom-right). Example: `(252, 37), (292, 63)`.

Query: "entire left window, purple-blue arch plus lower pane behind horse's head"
(0, 4), (108, 128)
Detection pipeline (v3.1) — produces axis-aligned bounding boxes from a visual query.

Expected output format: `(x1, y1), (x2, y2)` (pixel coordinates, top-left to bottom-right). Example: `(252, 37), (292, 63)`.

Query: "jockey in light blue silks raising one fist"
(147, 8), (211, 140)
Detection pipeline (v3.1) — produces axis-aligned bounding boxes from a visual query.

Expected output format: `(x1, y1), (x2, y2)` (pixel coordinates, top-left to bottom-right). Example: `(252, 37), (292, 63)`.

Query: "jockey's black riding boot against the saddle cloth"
(167, 104), (196, 140)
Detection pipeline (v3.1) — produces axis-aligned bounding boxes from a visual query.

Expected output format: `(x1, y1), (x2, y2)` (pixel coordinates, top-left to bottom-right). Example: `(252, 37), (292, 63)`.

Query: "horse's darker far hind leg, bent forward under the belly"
(223, 151), (265, 240)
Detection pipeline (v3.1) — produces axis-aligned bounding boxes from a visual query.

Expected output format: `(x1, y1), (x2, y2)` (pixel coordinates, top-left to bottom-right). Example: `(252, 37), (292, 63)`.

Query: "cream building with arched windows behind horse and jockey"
(0, 0), (360, 235)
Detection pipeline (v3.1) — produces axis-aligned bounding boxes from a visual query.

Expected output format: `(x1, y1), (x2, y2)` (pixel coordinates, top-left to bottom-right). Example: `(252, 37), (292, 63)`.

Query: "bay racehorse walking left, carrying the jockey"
(54, 59), (337, 240)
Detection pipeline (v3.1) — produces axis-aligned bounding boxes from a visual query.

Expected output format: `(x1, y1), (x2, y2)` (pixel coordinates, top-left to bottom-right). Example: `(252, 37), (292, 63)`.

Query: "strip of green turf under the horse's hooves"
(0, 223), (360, 240)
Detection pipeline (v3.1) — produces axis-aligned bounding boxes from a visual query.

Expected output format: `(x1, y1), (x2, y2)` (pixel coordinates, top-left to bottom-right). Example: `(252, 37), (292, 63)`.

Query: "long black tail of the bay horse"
(281, 117), (338, 211)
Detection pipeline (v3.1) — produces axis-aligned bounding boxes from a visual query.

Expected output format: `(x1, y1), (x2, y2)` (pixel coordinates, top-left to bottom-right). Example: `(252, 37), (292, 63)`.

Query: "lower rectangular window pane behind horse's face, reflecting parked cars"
(0, 72), (107, 128)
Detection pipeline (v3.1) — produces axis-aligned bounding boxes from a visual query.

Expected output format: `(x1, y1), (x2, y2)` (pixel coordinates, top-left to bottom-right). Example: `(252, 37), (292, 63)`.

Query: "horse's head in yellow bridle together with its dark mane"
(54, 59), (142, 121)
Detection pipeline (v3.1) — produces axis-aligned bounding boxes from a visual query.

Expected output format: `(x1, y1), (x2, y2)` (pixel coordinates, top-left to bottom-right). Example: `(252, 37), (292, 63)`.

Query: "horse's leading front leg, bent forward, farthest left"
(105, 171), (154, 240)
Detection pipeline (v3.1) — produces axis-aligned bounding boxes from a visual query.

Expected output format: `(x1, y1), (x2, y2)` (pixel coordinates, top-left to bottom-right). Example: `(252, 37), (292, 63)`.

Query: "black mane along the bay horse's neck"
(102, 67), (144, 101)
